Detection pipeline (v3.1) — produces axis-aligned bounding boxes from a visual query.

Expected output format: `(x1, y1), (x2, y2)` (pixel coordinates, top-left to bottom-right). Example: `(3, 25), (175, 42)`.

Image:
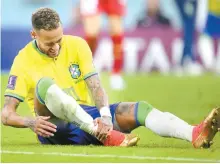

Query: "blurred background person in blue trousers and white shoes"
(175, 0), (203, 75)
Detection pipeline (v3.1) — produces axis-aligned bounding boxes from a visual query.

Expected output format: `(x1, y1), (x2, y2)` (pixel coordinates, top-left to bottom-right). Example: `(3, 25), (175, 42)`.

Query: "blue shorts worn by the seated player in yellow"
(38, 103), (119, 145)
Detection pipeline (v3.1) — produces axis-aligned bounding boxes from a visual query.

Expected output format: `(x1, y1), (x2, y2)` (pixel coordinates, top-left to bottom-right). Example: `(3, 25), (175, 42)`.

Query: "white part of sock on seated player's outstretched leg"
(145, 108), (193, 142)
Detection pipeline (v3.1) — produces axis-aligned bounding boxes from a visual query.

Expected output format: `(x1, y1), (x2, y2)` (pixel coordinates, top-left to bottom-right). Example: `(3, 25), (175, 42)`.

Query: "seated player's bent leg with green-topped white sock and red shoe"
(35, 78), (138, 146)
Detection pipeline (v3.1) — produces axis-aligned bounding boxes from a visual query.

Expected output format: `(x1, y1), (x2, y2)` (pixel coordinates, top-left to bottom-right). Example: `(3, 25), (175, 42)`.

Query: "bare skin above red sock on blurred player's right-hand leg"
(108, 15), (124, 35)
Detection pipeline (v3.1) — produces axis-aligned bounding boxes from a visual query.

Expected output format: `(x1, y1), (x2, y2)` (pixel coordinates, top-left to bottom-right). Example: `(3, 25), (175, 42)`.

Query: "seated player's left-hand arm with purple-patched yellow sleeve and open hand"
(1, 55), (56, 137)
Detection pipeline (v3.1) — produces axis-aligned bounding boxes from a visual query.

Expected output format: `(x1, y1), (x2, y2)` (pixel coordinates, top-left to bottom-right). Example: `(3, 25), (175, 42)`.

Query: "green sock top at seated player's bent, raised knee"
(35, 77), (54, 104)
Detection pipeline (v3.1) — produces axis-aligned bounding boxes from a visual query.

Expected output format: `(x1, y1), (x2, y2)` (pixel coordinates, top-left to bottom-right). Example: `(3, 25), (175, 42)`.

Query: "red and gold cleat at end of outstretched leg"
(192, 107), (220, 148)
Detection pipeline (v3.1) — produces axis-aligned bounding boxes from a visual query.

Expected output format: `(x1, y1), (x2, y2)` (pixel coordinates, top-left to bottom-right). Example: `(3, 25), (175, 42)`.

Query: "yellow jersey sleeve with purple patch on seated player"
(4, 56), (29, 101)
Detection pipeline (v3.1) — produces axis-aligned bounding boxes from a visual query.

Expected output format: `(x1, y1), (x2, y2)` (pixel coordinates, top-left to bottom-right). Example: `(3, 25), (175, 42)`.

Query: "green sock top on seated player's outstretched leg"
(136, 101), (153, 125)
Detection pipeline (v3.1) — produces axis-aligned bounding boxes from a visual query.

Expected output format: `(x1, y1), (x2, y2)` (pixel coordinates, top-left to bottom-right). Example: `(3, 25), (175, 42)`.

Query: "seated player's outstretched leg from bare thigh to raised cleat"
(115, 102), (220, 148)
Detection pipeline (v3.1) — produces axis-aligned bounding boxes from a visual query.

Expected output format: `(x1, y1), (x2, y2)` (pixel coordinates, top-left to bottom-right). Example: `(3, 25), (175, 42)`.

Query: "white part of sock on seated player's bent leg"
(45, 84), (96, 134)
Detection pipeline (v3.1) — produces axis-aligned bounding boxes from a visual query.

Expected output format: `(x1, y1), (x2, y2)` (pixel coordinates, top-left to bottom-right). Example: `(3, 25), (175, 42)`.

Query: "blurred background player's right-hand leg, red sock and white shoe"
(108, 15), (125, 90)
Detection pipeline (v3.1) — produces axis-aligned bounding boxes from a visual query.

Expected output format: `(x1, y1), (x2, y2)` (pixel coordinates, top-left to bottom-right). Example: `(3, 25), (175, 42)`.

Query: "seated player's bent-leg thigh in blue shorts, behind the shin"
(34, 102), (102, 145)
